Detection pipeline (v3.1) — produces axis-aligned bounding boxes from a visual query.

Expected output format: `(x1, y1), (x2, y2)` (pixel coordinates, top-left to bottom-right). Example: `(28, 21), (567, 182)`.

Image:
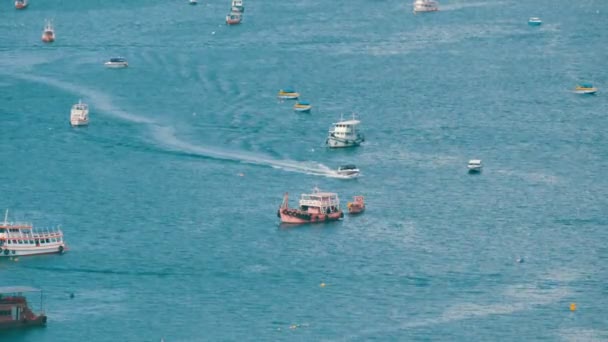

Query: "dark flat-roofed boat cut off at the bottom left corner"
(0, 286), (46, 330)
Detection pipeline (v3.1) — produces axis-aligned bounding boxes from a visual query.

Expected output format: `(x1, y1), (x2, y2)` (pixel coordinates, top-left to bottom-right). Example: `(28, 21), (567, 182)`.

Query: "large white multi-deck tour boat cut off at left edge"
(0, 210), (67, 257)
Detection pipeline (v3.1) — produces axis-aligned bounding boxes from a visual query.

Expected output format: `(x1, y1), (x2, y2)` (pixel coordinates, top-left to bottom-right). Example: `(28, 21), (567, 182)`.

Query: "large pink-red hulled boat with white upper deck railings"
(277, 188), (344, 223)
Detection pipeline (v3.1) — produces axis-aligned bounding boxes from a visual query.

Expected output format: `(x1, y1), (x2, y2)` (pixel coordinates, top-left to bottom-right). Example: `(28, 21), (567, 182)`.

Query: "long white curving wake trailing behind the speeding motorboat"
(10, 74), (344, 178)
